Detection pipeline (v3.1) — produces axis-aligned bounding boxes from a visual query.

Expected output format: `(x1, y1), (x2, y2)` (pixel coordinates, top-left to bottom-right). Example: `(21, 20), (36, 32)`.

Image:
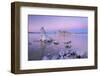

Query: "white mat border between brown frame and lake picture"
(20, 7), (94, 70)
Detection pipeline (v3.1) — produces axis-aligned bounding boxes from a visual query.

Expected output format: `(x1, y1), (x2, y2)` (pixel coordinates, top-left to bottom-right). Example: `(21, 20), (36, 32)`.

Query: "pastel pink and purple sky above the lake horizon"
(28, 15), (88, 33)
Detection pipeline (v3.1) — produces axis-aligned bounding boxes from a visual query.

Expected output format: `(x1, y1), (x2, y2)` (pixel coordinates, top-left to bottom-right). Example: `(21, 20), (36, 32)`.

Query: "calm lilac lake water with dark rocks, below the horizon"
(28, 33), (88, 60)
